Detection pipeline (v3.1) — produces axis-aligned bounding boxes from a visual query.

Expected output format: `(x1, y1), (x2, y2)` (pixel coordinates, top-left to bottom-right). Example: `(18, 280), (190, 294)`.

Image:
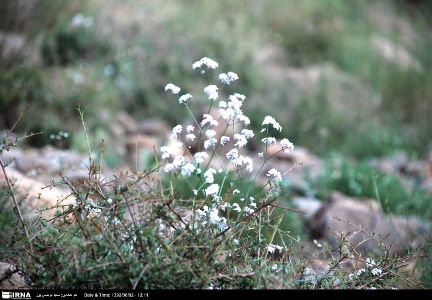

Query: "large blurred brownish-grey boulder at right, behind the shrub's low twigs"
(306, 191), (429, 256)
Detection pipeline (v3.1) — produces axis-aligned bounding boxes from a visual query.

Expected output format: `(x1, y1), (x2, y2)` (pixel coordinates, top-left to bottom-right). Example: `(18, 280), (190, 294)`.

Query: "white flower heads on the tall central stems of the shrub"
(160, 57), (294, 231)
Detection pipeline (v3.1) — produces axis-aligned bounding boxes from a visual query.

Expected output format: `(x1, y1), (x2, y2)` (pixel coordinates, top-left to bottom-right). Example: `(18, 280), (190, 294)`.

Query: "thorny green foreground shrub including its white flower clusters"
(0, 58), (428, 289)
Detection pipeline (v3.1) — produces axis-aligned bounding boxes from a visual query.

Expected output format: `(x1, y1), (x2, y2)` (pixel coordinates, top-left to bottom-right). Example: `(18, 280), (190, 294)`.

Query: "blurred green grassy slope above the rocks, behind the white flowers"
(0, 0), (432, 164)
